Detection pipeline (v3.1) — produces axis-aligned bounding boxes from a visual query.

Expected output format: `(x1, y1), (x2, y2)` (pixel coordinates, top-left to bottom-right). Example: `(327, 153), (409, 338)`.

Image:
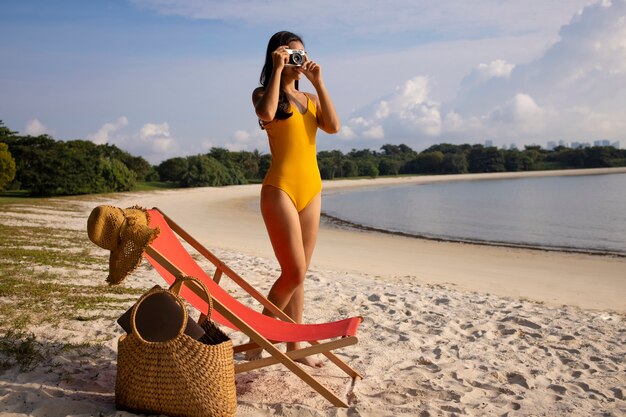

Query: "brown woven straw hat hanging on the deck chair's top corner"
(87, 206), (159, 285)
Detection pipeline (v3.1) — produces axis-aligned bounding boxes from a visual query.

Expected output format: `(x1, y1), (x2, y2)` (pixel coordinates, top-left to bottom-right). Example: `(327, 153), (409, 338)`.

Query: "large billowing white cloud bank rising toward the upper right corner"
(344, 0), (626, 149)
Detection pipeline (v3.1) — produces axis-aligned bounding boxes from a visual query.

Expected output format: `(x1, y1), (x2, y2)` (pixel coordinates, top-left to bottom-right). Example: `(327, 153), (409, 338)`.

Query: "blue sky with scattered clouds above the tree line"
(0, 0), (626, 163)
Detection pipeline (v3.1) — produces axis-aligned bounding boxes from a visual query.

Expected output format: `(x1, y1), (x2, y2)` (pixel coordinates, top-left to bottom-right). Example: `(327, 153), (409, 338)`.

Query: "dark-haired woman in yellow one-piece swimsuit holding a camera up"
(248, 32), (339, 367)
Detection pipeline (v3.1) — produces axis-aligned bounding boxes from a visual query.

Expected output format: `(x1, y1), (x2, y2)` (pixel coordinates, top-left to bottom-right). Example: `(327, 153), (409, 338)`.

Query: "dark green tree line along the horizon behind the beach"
(0, 121), (626, 196)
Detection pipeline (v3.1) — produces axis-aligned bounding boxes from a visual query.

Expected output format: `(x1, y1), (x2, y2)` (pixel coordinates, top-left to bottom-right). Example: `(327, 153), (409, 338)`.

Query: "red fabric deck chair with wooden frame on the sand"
(146, 208), (362, 407)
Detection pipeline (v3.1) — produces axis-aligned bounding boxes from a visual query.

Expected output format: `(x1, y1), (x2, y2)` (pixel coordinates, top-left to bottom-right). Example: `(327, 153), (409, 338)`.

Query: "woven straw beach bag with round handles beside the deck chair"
(115, 277), (237, 417)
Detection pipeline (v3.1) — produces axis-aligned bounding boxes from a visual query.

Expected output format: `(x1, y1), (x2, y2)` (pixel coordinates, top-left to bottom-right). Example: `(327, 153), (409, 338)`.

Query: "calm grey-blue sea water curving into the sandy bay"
(322, 174), (626, 255)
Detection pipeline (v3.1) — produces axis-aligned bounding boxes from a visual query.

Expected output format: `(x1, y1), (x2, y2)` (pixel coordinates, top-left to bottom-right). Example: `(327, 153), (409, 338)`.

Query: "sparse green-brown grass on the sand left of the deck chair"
(0, 199), (144, 336)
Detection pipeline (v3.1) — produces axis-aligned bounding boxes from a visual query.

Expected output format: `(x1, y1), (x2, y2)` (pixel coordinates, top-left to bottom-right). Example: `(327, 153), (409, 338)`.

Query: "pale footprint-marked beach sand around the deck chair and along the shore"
(0, 170), (626, 417)
